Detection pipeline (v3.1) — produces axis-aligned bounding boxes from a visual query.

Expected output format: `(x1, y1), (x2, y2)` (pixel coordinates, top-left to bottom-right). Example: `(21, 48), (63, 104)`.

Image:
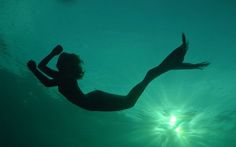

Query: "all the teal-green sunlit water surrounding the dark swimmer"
(0, 0), (236, 147)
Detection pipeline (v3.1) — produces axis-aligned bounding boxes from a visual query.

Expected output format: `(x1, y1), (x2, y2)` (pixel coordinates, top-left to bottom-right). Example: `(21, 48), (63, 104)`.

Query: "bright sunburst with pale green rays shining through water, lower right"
(123, 88), (236, 147)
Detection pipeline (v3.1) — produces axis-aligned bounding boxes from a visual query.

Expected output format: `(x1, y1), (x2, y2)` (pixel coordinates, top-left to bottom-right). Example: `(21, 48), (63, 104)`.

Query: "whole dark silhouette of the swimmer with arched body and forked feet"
(27, 34), (209, 111)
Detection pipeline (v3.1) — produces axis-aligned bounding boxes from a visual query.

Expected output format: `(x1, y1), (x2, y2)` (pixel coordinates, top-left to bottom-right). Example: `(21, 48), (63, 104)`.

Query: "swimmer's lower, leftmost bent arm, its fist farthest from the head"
(27, 60), (58, 87)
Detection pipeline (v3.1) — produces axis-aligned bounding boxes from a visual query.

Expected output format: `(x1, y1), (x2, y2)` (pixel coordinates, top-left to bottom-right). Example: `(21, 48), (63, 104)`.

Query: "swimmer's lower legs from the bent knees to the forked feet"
(126, 34), (209, 108)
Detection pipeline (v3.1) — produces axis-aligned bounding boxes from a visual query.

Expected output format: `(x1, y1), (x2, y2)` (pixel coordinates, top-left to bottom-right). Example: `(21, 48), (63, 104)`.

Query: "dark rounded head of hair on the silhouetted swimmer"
(57, 52), (84, 79)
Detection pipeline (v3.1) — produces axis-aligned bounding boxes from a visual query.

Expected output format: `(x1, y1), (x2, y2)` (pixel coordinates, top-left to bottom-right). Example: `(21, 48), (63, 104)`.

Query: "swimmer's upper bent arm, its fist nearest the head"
(38, 45), (63, 78)
